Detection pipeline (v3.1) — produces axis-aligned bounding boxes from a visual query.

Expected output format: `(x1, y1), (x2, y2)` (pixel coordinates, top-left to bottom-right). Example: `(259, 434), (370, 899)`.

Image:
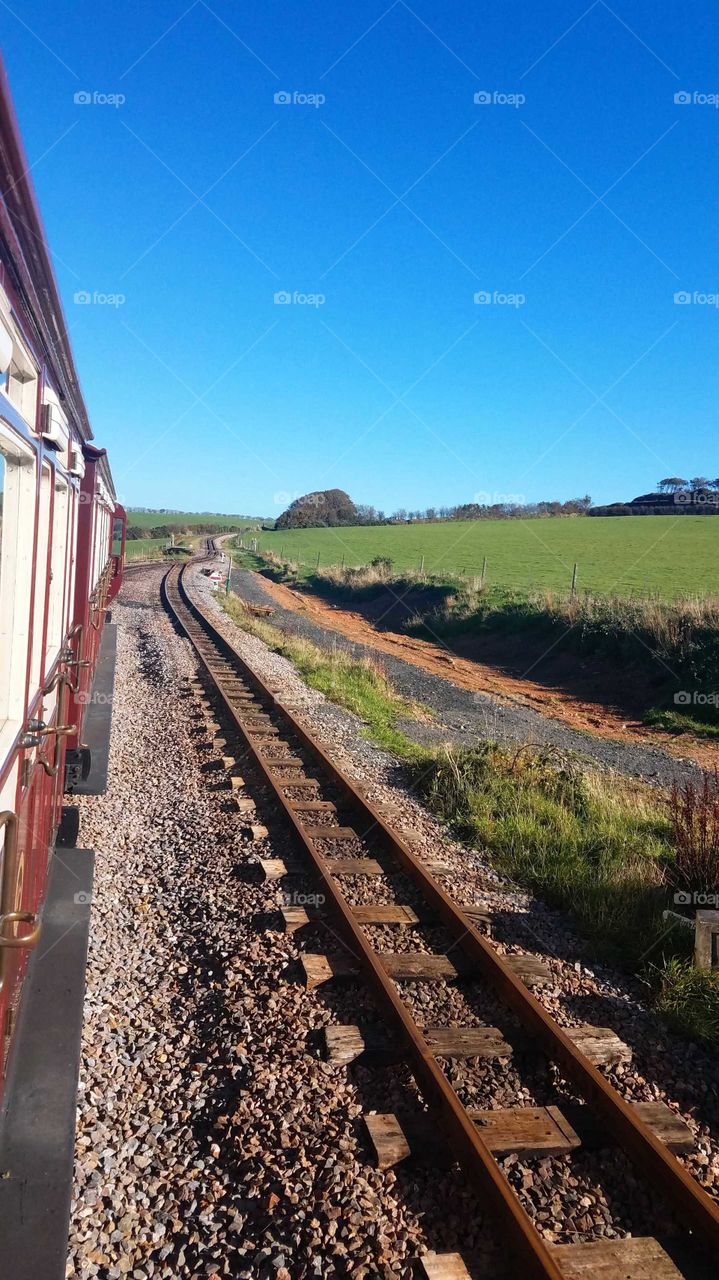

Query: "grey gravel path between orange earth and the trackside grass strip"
(225, 567), (701, 786)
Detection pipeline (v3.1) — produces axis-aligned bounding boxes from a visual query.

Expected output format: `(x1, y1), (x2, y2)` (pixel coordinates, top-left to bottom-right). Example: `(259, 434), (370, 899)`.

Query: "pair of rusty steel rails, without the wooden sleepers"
(164, 555), (719, 1280)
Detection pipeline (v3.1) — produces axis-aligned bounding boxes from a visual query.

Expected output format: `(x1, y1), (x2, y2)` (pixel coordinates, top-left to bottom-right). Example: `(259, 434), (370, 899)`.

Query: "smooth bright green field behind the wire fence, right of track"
(256, 516), (719, 599)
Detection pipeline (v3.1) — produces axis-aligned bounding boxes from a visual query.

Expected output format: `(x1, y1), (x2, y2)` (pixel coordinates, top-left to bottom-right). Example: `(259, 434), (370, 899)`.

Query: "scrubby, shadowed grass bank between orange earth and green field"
(227, 535), (719, 737)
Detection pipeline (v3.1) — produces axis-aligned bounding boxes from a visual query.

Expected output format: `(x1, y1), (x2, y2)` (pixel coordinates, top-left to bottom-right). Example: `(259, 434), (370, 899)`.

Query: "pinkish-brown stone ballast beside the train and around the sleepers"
(67, 568), (719, 1280)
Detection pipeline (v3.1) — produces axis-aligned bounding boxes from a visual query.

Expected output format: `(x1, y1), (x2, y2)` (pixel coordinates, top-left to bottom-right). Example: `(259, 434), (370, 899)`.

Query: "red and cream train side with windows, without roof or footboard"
(0, 238), (125, 1076)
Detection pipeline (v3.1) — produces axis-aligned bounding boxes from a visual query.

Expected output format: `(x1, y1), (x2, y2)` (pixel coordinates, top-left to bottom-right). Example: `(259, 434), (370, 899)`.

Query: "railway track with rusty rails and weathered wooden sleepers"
(164, 543), (719, 1280)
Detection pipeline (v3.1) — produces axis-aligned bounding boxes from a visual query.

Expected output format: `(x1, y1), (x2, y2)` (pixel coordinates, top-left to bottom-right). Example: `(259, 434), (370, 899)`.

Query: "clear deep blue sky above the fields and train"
(0, 0), (719, 515)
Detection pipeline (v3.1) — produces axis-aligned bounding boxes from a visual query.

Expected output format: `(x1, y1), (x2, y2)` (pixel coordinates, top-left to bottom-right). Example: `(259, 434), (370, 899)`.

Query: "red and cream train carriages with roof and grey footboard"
(0, 57), (125, 1280)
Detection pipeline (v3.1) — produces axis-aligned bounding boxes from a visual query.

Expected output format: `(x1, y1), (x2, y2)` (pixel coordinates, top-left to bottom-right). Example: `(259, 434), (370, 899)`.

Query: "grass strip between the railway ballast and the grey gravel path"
(221, 595), (719, 1042)
